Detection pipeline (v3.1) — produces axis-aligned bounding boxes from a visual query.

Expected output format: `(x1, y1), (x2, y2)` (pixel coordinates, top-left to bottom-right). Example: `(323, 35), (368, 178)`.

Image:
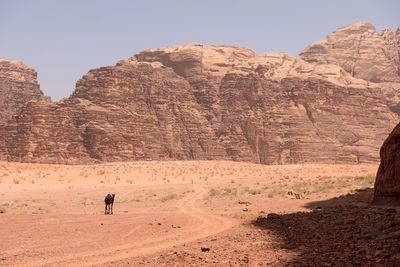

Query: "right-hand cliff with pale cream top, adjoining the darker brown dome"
(136, 44), (398, 164)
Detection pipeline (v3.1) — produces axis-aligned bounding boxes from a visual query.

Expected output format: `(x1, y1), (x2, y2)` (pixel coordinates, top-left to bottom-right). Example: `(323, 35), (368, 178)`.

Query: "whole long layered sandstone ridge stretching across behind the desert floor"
(0, 23), (400, 164)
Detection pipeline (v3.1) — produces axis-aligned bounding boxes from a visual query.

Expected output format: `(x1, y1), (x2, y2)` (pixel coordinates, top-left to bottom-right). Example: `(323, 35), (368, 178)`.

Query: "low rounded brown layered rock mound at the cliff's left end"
(0, 101), (90, 164)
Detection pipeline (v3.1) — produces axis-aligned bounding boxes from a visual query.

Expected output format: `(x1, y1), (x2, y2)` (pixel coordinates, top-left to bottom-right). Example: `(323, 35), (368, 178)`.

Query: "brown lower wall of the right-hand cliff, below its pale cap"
(217, 74), (397, 164)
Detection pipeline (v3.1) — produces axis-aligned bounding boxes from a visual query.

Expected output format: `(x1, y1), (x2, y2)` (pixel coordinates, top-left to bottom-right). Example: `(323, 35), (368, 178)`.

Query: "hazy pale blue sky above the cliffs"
(0, 0), (400, 100)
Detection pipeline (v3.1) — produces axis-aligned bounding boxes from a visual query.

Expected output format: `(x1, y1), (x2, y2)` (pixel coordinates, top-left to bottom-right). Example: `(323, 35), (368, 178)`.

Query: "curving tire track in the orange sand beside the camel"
(20, 188), (237, 266)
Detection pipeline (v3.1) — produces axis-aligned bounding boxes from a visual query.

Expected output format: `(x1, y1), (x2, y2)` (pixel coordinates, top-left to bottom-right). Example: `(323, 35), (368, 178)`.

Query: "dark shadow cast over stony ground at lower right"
(253, 189), (400, 266)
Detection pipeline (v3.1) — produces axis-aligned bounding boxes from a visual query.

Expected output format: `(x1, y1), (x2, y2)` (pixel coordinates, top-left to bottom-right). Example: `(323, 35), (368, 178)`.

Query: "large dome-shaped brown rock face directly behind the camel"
(60, 61), (227, 161)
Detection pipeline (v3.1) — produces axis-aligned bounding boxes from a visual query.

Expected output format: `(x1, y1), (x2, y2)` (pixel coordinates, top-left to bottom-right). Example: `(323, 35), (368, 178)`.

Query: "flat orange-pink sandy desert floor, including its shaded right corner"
(0, 161), (400, 266)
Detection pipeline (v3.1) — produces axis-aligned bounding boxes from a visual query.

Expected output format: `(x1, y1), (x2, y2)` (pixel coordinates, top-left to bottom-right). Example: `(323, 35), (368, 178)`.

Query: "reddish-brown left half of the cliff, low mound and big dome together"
(0, 62), (228, 163)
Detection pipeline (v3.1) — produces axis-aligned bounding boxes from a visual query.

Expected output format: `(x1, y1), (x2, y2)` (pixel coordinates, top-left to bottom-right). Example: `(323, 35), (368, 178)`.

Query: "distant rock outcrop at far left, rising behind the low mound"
(0, 58), (50, 124)
